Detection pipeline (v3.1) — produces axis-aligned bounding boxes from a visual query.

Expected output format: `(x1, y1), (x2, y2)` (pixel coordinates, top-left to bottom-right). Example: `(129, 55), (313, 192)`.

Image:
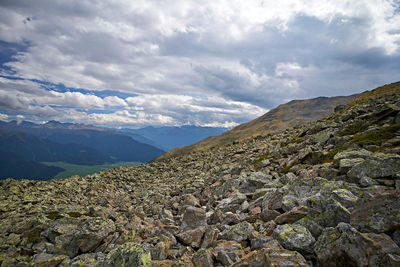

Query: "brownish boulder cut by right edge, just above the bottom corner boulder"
(350, 193), (400, 233)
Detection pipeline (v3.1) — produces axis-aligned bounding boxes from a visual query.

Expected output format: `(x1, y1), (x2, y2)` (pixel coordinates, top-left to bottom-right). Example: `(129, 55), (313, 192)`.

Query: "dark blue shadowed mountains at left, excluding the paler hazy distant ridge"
(0, 121), (165, 179)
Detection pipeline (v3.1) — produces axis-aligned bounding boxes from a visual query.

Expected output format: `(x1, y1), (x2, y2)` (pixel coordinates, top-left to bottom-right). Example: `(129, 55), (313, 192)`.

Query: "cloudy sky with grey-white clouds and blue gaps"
(0, 0), (400, 127)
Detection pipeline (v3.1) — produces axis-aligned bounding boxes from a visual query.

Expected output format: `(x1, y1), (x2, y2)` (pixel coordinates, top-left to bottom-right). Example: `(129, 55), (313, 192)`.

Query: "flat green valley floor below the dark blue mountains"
(42, 161), (141, 179)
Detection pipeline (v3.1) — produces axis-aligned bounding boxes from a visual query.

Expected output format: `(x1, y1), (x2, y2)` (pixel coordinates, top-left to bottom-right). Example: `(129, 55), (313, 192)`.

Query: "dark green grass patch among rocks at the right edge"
(351, 124), (400, 146)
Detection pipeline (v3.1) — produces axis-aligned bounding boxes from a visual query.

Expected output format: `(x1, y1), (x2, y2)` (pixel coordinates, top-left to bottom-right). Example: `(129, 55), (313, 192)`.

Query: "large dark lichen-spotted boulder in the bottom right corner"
(314, 223), (400, 267)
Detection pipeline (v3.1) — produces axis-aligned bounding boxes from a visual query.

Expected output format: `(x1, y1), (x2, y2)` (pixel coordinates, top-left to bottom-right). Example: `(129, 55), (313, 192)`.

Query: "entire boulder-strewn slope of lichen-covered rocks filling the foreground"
(0, 83), (400, 267)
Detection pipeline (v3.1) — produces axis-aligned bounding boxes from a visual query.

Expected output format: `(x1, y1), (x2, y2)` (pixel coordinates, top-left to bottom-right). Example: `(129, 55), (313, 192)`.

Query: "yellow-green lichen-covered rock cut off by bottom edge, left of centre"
(100, 242), (151, 267)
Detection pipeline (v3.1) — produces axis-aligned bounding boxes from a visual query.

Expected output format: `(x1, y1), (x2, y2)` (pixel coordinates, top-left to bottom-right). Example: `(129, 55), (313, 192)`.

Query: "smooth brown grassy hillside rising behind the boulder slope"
(160, 94), (360, 159)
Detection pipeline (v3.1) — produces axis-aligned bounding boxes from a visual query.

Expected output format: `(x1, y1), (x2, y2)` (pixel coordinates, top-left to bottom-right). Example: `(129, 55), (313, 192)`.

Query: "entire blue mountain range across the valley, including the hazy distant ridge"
(0, 121), (225, 179)
